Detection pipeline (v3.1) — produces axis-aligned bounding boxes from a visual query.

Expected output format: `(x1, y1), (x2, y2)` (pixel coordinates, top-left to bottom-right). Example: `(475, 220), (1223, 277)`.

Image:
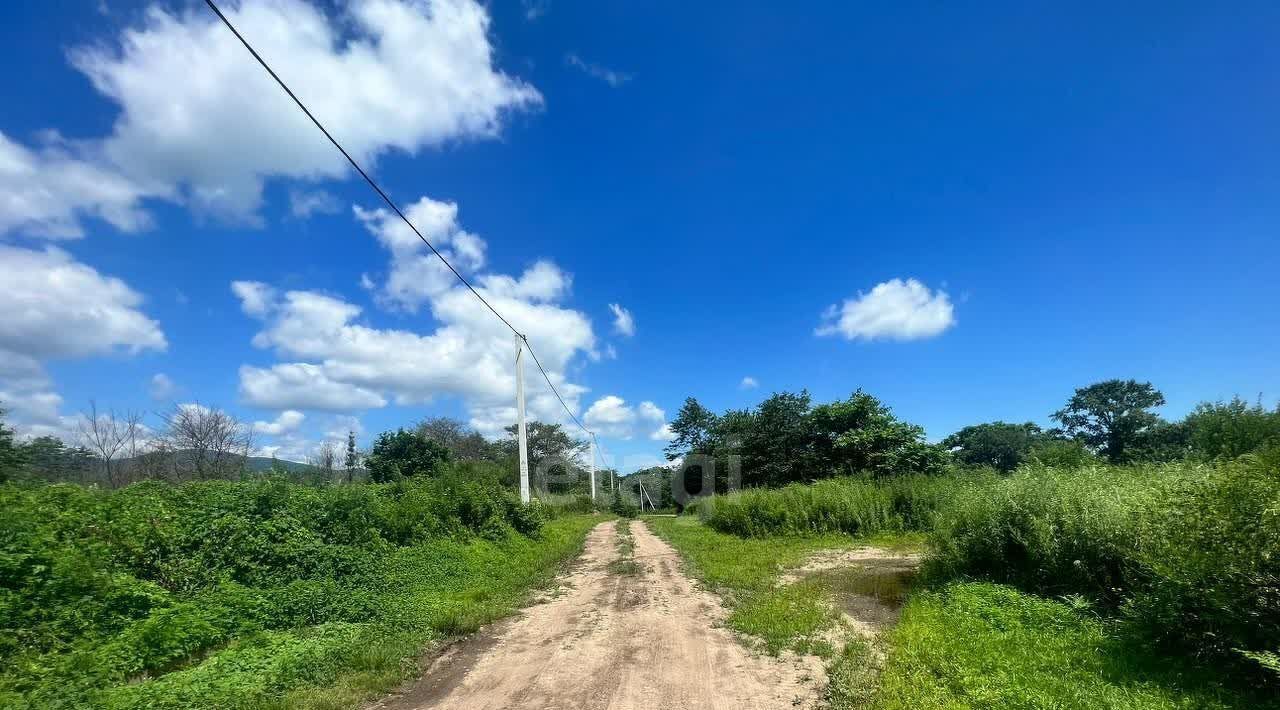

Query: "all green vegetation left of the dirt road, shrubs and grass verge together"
(0, 411), (598, 710)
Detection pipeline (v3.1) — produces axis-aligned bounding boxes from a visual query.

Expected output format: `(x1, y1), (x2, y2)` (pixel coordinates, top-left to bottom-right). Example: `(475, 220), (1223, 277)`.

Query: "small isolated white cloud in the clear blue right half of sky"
(814, 279), (956, 340)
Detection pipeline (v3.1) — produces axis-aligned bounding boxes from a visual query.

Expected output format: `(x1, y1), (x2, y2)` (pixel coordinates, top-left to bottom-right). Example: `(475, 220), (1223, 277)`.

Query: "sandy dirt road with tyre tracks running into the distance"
(372, 521), (824, 710)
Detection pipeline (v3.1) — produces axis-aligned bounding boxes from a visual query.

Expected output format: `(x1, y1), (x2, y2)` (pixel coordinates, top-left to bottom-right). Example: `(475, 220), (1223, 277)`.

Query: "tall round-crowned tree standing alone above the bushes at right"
(1052, 380), (1165, 463)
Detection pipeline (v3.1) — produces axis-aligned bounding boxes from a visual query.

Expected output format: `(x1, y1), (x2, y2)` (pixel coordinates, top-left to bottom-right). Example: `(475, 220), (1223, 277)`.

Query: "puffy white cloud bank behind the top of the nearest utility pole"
(233, 252), (595, 436)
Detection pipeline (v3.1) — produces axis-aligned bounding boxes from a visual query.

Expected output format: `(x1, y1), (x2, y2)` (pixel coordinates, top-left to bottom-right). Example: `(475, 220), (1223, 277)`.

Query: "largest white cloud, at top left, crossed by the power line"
(0, 0), (541, 237)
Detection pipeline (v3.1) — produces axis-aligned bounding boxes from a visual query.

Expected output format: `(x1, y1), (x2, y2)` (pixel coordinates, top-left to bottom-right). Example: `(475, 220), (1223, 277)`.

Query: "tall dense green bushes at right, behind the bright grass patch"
(927, 457), (1280, 670)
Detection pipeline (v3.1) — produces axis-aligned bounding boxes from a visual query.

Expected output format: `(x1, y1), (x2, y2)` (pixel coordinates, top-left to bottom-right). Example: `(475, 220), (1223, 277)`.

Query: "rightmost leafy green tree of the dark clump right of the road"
(810, 390), (947, 477)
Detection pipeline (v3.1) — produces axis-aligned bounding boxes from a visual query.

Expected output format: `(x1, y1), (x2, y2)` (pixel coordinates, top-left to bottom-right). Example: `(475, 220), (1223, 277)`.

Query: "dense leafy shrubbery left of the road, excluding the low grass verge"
(0, 471), (576, 706)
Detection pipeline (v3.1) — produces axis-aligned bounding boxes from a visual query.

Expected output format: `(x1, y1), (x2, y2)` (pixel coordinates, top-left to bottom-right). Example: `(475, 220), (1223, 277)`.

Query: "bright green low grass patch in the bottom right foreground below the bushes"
(870, 582), (1276, 710)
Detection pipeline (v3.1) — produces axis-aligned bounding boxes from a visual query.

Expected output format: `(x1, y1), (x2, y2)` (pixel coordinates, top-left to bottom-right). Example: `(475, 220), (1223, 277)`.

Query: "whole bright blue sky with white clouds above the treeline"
(0, 0), (1280, 468)
